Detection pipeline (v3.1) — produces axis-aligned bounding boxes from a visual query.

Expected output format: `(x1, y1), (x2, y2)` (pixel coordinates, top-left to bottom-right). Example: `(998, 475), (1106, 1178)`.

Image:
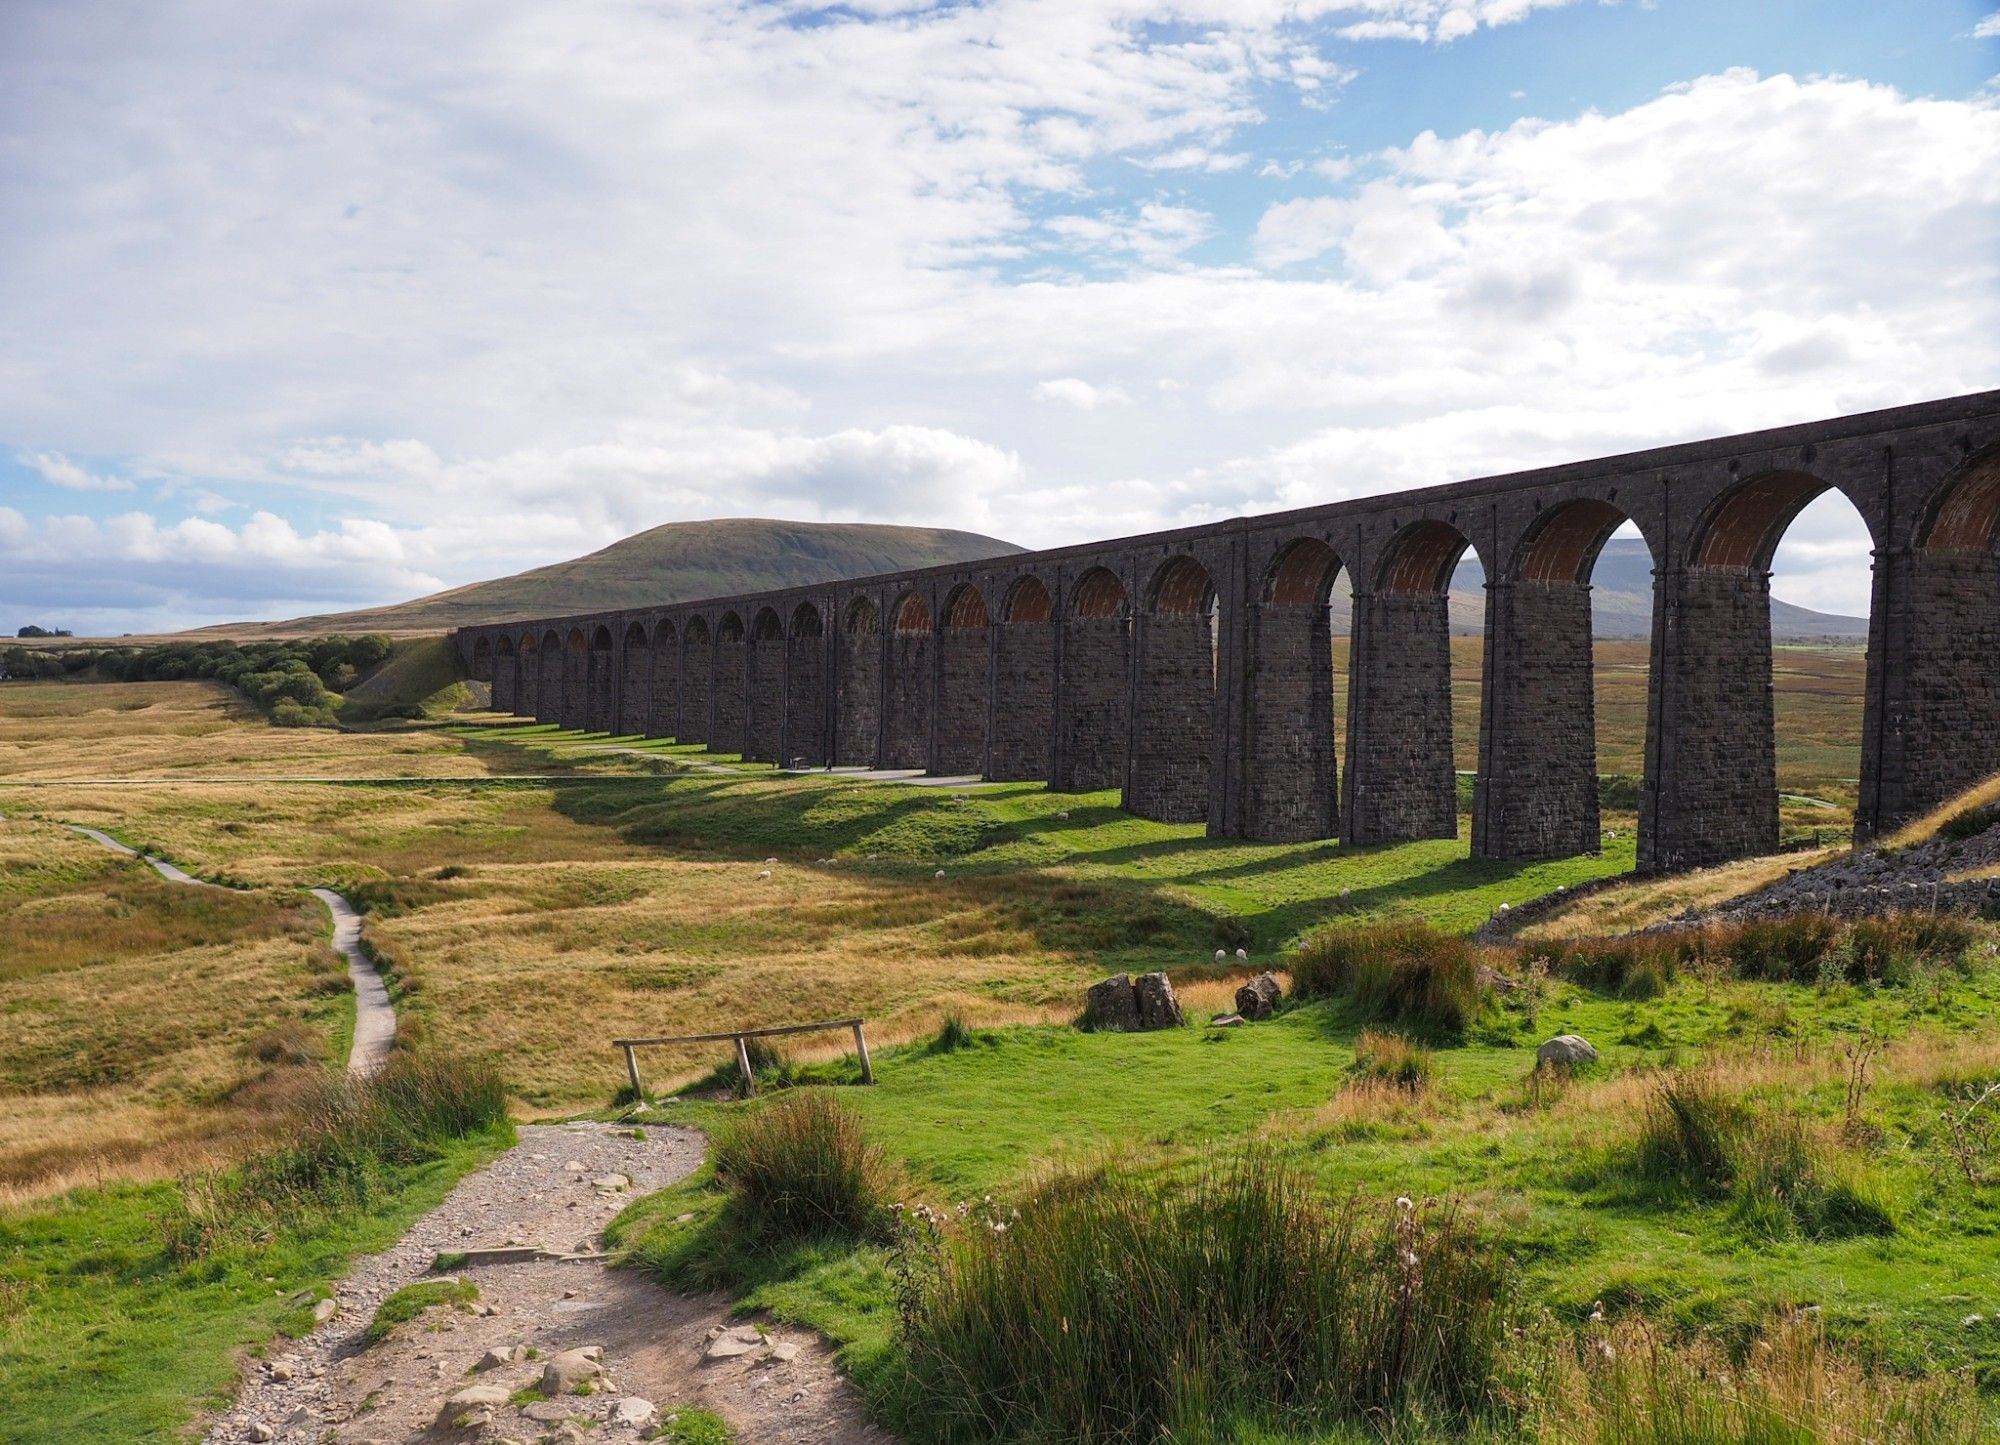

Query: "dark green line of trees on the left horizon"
(0, 632), (390, 727)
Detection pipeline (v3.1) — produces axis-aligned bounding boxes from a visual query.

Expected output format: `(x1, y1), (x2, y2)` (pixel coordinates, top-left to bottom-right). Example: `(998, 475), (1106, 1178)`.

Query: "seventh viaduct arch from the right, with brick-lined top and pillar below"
(1052, 566), (1132, 793)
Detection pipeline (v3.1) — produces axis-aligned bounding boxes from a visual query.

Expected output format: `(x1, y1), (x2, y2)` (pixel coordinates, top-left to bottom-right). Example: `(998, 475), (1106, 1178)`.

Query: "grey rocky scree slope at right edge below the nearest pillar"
(1702, 808), (2000, 921)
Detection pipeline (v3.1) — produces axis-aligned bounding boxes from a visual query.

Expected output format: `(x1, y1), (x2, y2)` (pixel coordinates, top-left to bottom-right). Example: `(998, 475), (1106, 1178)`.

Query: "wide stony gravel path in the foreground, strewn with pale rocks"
(208, 1123), (888, 1445)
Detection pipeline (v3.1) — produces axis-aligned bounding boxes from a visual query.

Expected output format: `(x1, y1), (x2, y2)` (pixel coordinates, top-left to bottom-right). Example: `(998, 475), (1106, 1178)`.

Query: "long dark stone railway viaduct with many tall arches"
(458, 392), (2000, 871)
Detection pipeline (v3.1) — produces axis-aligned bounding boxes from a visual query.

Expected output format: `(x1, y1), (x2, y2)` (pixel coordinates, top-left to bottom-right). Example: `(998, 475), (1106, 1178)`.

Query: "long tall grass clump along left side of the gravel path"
(160, 1051), (506, 1261)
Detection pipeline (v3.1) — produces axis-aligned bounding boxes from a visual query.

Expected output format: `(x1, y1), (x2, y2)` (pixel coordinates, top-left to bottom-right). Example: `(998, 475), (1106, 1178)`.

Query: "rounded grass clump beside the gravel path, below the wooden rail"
(714, 1089), (894, 1247)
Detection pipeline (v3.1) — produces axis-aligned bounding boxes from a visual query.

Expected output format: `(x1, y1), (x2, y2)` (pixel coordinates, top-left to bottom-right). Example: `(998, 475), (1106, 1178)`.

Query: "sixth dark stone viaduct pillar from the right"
(1124, 610), (1216, 823)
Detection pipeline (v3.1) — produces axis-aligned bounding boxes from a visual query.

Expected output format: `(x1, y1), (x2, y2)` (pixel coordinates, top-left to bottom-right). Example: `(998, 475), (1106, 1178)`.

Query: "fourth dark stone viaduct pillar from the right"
(1344, 590), (1458, 843)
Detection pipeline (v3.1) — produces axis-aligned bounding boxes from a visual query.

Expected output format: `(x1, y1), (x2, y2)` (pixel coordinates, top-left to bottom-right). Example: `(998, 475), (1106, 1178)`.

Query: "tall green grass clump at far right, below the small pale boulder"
(1632, 1071), (1896, 1239)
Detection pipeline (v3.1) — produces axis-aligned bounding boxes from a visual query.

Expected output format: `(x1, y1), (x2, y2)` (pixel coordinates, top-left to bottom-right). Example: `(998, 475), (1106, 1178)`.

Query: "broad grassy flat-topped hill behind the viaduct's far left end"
(184, 518), (1022, 638)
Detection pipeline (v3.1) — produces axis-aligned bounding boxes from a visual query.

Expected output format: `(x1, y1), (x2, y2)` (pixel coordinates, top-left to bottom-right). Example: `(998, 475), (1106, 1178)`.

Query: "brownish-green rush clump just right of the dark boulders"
(1292, 923), (1488, 1037)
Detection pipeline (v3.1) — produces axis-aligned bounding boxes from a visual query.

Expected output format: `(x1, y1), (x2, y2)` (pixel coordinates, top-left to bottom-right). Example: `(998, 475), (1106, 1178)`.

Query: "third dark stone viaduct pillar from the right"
(1472, 580), (1598, 859)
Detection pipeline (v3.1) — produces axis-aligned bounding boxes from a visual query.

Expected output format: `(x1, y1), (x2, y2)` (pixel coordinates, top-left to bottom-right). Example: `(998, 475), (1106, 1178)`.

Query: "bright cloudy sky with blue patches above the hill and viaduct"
(0, 0), (2000, 632)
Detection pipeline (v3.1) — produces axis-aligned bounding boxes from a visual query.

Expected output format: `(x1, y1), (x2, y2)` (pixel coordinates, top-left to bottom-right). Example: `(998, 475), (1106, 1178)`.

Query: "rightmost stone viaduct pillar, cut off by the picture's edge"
(1854, 550), (2000, 839)
